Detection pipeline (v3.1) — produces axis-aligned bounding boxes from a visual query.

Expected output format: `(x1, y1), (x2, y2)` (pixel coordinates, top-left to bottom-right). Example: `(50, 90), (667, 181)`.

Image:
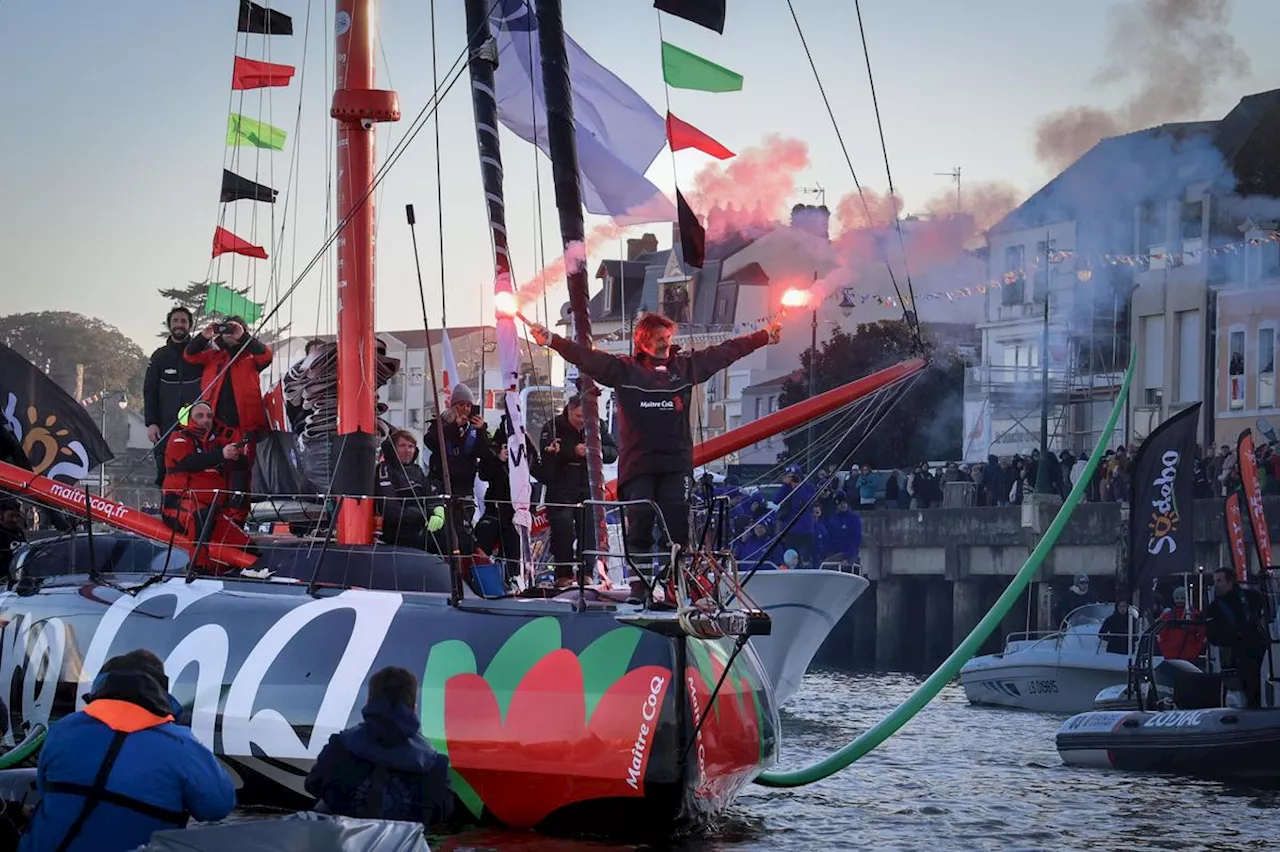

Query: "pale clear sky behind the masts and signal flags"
(0, 0), (1280, 349)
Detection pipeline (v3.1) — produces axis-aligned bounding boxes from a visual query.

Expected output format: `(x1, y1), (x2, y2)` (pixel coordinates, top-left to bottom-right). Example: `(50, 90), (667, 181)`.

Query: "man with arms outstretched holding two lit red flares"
(530, 313), (782, 578)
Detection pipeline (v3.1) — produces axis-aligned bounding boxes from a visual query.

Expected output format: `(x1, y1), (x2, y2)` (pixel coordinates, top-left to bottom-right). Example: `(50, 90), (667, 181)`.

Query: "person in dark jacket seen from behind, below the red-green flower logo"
(305, 667), (453, 825)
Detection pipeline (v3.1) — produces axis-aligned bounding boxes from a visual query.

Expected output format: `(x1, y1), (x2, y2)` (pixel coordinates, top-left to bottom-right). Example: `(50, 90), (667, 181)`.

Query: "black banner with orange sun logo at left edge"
(0, 344), (114, 485)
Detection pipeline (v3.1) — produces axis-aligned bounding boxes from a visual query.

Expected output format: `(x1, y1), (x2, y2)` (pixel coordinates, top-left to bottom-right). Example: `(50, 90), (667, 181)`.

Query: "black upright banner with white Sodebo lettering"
(1129, 403), (1201, 605)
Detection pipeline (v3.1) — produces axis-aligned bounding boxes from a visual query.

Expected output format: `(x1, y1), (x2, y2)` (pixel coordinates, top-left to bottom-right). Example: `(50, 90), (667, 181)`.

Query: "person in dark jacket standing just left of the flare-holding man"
(539, 394), (618, 585)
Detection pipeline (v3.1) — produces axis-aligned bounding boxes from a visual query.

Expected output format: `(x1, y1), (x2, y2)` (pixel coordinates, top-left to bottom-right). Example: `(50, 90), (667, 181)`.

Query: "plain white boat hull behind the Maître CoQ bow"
(745, 569), (870, 706)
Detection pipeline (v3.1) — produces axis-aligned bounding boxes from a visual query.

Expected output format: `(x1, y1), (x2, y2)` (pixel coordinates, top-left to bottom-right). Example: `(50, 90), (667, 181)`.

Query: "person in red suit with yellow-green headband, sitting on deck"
(160, 402), (252, 568)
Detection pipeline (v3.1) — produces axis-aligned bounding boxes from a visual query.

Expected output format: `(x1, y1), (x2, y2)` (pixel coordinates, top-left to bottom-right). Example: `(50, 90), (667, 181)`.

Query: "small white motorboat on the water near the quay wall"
(960, 604), (1137, 713)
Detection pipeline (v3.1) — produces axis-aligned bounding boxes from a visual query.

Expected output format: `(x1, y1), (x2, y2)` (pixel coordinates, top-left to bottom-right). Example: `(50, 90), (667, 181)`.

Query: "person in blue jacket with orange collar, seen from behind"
(18, 649), (236, 852)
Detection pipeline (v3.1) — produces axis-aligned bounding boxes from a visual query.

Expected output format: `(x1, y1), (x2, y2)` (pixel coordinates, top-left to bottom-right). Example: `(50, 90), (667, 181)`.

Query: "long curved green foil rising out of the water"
(755, 347), (1138, 787)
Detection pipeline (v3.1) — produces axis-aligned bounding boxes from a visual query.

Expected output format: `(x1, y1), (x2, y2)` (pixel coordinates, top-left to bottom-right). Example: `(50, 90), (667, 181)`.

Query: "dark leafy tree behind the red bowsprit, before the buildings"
(778, 320), (965, 469)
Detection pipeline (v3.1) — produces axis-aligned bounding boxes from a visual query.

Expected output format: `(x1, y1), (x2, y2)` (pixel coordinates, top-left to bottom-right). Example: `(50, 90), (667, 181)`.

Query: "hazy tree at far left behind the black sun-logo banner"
(0, 311), (147, 406)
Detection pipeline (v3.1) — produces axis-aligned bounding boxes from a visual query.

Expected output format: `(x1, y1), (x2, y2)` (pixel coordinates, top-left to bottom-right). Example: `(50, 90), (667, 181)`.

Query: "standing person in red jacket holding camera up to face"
(183, 316), (271, 523)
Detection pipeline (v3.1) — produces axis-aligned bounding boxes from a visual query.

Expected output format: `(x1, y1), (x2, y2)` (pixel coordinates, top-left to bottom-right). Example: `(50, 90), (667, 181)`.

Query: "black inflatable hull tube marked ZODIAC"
(1057, 707), (1280, 780)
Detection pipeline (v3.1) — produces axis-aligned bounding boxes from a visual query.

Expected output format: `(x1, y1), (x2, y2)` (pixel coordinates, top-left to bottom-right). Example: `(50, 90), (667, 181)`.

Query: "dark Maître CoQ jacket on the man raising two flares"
(550, 331), (769, 485)
